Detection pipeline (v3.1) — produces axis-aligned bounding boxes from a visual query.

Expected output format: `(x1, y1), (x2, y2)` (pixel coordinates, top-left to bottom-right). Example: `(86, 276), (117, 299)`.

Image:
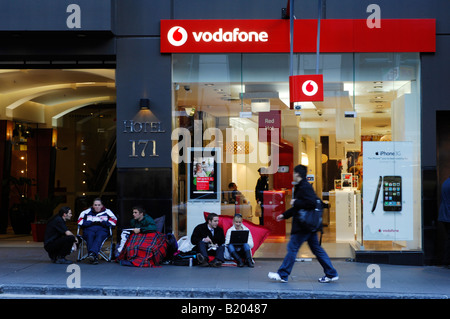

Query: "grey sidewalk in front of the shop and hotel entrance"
(0, 242), (450, 299)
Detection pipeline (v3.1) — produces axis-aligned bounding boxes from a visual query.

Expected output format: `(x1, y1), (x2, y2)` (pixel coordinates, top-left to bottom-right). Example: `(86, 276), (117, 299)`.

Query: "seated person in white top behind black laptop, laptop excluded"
(225, 214), (255, 268)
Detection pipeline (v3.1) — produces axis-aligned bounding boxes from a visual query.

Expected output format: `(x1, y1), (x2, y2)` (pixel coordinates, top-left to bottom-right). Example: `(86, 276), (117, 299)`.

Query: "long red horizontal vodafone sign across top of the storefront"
(161, 19), (436, 53)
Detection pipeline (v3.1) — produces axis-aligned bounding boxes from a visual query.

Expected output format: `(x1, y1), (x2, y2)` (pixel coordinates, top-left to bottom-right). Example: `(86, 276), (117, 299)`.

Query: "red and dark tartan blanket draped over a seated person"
(117, 232), (168, 267)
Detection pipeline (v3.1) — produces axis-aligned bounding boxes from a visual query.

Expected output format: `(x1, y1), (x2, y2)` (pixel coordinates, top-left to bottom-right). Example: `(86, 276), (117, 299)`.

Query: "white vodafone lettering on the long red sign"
(192, 28), (269, 42)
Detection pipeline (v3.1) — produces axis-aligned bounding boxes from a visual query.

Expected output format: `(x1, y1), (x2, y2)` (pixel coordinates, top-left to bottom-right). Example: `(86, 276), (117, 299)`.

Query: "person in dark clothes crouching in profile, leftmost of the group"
(44, 207), (78, 264)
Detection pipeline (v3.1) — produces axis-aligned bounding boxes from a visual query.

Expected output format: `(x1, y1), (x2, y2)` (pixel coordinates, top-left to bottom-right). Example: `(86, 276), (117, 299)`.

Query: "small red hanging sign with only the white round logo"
(289, 74), (323, 104)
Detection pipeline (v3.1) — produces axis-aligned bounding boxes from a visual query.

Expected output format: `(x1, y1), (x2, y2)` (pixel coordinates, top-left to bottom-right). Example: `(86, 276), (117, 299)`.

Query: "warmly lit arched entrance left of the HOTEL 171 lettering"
(0, 68), (116, 235)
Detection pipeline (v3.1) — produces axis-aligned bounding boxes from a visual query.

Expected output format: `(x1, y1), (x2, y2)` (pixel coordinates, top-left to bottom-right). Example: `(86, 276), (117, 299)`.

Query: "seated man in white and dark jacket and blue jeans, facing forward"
(78, 198), (117, 265)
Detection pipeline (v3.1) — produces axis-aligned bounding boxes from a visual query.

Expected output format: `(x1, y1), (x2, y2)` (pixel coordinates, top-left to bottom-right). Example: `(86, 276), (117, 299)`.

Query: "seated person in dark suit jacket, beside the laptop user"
(191, 213), (225, 267)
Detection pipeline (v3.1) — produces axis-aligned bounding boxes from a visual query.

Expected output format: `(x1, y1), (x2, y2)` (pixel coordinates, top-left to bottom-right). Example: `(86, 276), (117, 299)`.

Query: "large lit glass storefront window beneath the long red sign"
(172, 53), (421, 257)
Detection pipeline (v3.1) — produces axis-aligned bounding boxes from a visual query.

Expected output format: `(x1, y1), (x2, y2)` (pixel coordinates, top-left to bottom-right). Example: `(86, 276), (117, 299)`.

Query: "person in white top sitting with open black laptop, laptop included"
(225, 214), (255, 268)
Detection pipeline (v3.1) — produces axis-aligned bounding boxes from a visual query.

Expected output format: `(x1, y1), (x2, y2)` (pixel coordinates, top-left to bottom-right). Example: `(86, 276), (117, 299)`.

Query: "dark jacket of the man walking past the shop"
(282, 179), (317, 234)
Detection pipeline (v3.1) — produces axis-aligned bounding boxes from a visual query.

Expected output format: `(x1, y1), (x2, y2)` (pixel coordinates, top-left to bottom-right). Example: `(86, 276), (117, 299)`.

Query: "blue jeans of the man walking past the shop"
(278, 233), (338, 280)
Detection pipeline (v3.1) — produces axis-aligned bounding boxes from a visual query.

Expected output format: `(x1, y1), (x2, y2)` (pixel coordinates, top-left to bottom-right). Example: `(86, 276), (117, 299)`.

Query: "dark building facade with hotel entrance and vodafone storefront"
(0, 0), (450, 264)
